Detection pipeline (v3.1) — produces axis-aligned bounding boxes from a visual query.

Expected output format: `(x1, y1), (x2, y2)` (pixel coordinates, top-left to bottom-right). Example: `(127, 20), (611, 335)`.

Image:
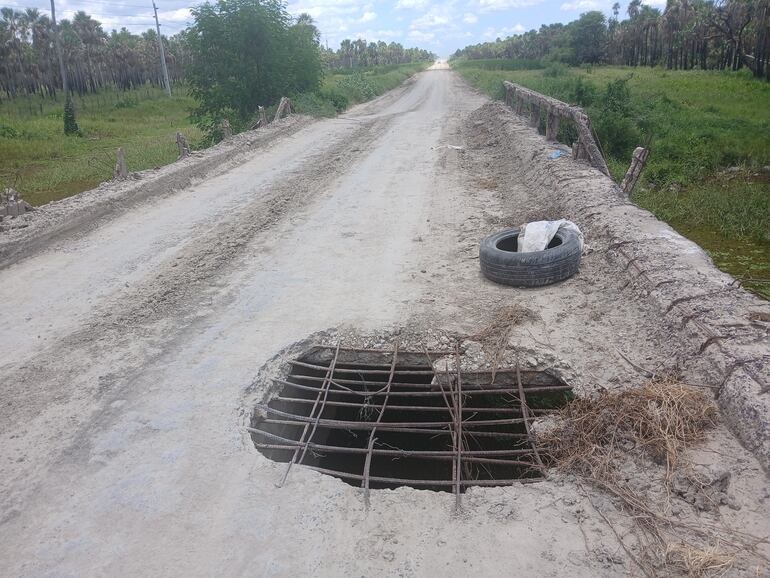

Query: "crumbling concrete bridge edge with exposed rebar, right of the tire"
(490, 103), (770, 473)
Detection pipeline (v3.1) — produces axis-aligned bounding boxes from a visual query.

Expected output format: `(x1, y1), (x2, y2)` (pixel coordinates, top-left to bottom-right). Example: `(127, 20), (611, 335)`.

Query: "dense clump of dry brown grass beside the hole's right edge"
(541, 380), (718, 479)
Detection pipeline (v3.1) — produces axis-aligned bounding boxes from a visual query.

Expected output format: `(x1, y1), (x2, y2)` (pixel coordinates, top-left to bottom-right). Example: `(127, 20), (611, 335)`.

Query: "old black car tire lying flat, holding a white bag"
(479, 228), (581, 287)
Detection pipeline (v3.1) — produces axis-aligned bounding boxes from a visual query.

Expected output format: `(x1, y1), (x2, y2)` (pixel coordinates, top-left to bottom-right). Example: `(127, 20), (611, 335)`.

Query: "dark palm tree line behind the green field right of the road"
(454, 0), (770, 81)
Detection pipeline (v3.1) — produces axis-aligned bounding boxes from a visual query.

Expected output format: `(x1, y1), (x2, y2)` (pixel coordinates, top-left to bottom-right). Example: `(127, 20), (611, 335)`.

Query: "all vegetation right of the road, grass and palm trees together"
(451, 0), (770, 298)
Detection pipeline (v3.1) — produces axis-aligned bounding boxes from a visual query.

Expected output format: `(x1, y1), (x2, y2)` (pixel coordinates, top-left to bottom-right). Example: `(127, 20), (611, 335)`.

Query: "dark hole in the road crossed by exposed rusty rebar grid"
(249, 347), (571, 493)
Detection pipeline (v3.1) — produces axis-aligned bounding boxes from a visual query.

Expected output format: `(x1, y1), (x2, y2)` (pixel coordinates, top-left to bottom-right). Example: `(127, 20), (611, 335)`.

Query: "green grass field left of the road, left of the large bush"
(0, 87), (201, 205)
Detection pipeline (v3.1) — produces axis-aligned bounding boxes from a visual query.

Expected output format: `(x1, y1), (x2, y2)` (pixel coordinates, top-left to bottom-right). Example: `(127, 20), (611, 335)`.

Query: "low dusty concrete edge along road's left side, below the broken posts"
(0, 115), (316, 269)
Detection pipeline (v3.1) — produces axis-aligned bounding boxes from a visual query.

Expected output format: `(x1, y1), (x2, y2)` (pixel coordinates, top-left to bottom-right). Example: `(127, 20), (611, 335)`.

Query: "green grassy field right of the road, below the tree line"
(453, 61), (770, 298)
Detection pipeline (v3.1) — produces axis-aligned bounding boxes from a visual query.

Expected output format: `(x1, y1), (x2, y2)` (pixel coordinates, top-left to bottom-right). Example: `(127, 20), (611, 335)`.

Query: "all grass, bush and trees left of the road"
(0, 0), (434, 205)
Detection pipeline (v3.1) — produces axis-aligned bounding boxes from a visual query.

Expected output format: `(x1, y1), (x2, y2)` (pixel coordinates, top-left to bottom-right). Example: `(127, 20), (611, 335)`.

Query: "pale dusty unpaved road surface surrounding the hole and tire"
(0, 69), (770, 576)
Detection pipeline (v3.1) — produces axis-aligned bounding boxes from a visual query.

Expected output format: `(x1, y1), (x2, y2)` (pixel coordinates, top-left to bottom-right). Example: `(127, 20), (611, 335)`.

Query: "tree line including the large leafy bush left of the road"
(0, 0), (433, 101)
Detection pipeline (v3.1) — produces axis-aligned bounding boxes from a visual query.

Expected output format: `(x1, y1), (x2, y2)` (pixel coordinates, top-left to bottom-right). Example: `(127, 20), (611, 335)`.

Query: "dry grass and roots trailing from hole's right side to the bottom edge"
(538, 380), (756, 576)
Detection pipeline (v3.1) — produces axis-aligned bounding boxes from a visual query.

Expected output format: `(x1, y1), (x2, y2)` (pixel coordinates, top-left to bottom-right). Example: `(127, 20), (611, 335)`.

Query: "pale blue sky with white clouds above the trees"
(6, 0), (666, 56)
